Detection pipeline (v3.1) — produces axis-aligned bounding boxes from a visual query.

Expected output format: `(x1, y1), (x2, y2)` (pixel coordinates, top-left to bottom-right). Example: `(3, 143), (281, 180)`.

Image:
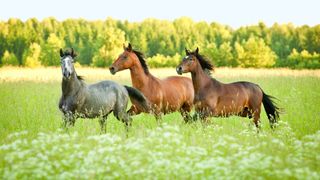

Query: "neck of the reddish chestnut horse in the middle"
(130, 60), (152, 89)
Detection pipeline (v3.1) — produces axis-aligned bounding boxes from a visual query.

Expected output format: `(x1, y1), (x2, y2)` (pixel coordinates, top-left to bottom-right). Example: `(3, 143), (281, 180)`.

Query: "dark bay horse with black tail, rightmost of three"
(176, 48), (279, 128)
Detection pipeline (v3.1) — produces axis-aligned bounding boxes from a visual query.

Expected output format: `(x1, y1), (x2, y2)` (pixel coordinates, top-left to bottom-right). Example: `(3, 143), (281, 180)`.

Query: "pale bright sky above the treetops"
(0, 0), (320, 28)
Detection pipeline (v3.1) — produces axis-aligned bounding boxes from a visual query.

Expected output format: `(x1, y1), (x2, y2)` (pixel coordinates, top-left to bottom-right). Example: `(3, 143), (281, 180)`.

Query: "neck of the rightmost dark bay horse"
(191, 64), (212, 93)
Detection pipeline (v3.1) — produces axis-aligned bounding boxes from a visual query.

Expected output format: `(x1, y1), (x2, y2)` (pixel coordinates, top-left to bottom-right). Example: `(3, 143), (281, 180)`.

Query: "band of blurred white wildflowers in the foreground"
(0, 124), (320, 179)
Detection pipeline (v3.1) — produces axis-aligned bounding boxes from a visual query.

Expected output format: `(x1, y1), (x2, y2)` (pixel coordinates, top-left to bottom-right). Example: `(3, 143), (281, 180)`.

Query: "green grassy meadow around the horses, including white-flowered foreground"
(0, 68), (320, 179)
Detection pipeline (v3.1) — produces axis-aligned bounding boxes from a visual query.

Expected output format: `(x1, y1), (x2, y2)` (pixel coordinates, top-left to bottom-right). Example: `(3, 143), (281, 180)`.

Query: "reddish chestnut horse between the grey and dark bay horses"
(110, 44), (194, 122)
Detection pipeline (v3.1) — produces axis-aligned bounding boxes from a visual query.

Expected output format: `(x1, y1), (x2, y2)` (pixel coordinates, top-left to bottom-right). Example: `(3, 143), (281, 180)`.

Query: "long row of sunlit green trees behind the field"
(0, 17), (320, 69)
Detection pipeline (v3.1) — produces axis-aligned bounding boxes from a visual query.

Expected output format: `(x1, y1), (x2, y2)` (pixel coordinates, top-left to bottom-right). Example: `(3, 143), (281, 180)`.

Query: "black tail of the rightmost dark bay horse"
(262, 91), (280, 128)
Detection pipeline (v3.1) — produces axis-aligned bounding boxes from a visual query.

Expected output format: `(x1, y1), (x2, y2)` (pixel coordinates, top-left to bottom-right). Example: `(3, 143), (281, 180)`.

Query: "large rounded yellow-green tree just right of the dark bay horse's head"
(235, 37), (276, 67)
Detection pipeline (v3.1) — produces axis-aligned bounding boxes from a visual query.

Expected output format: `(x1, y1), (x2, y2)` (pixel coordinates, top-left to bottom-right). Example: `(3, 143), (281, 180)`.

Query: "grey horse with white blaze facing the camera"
(59, 49), (148, 132)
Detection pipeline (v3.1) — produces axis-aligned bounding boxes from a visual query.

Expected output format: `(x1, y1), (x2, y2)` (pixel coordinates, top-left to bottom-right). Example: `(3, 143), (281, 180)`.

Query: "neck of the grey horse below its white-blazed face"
(62, 73), (84, 96)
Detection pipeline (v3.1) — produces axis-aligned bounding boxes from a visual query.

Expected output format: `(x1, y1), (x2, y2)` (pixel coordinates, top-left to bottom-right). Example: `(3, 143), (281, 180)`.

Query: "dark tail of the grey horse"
(124, 86), (150, 112)
